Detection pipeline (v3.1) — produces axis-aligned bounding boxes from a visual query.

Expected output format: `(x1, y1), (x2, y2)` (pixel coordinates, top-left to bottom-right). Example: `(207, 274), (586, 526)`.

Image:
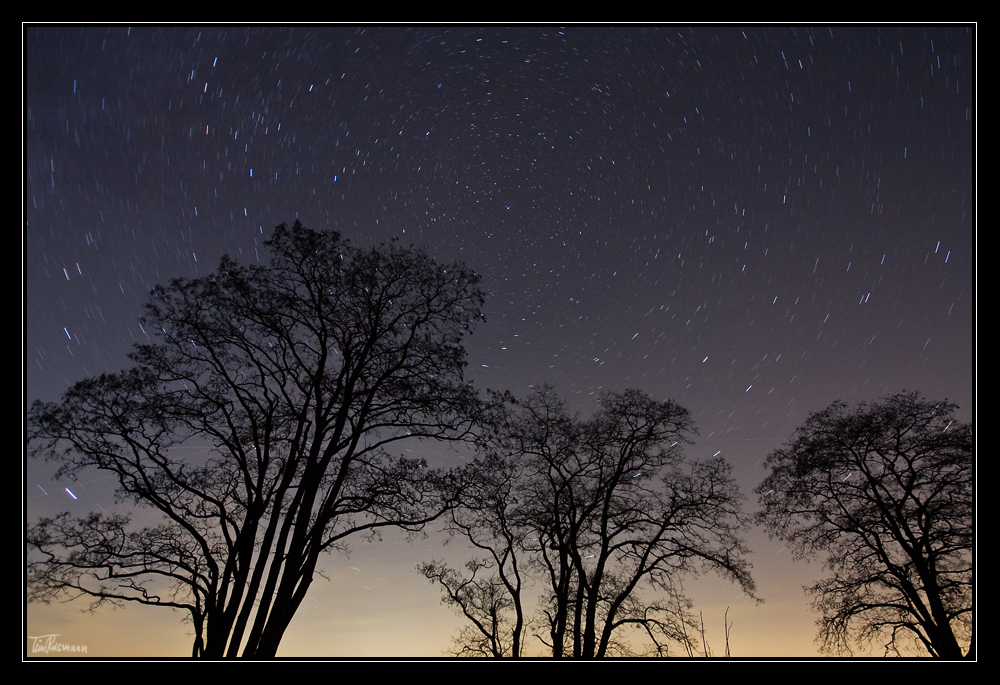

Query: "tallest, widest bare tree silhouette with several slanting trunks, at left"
(27, 222), (483, 657)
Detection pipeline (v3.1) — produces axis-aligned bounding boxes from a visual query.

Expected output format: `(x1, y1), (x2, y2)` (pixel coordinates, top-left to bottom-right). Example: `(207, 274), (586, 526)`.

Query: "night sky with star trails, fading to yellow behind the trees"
(22, 25), (976, 657)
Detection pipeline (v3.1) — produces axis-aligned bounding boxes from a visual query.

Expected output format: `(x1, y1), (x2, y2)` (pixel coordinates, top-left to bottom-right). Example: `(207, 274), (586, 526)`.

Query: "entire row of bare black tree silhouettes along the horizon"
(25, 222), (975, 658)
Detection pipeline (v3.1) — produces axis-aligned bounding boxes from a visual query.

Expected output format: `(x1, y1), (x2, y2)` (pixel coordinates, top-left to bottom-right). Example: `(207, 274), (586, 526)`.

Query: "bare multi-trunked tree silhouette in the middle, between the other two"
(421, 388), (754, 658)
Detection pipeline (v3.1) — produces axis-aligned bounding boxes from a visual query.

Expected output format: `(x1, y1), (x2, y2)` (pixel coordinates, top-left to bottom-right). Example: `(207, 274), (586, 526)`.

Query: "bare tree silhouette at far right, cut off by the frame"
(756, 393), (974, 658)
